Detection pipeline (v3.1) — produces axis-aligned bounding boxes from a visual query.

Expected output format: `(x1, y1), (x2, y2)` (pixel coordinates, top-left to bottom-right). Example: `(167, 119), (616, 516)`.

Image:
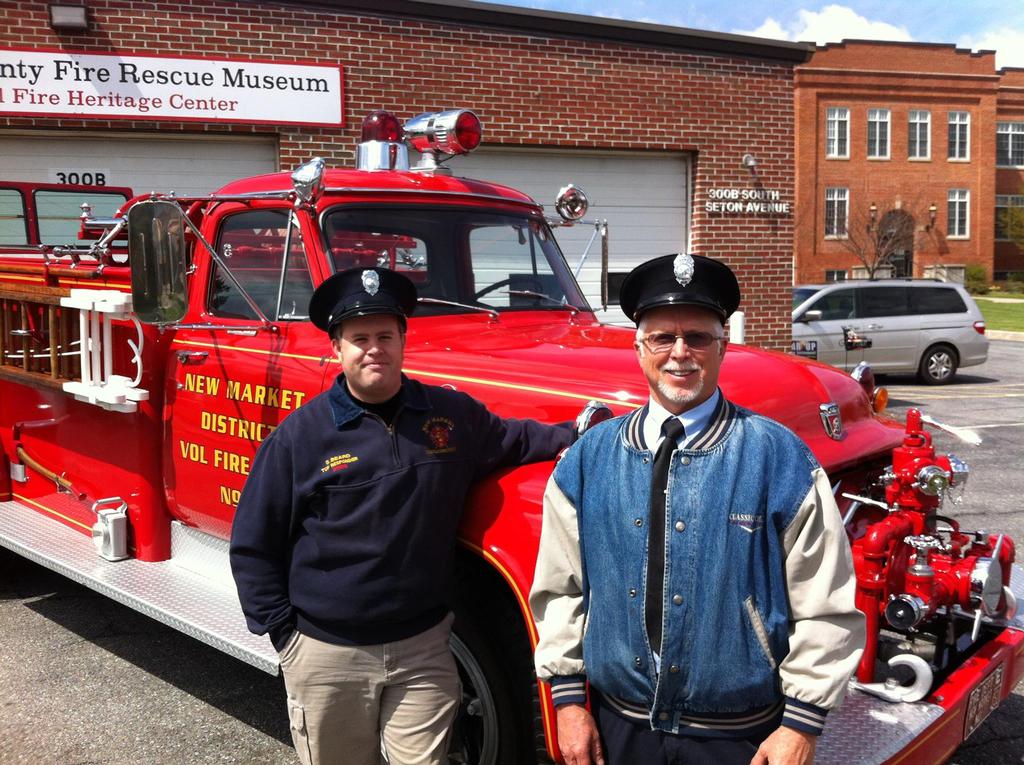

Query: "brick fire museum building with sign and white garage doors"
(0, 0), (810, 347)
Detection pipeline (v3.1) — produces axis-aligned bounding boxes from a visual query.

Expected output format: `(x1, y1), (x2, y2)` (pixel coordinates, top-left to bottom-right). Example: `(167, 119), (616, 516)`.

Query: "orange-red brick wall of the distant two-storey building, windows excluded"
(795, 42), (1024, 282)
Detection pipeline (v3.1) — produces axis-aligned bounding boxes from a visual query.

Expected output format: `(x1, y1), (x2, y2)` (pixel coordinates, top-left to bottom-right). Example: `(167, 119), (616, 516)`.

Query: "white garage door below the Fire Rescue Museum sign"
(0, 133), (278, 195)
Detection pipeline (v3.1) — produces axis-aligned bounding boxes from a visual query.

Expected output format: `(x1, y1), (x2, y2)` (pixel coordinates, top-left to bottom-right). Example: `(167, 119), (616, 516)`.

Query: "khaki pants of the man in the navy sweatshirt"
(281, 614), (461, 765)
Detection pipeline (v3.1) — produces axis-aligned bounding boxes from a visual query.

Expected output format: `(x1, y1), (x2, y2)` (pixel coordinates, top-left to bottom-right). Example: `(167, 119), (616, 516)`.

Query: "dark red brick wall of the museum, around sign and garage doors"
(0, 0), (794, 348)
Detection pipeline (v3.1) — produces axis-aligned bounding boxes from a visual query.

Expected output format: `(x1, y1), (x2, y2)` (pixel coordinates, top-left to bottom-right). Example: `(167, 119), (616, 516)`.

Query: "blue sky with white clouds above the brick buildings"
(486, 0), (1024, 67)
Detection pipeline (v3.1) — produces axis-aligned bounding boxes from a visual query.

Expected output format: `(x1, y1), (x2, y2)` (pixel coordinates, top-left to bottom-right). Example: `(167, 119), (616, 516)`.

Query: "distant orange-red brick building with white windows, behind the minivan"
(795, 41), (1024, 282)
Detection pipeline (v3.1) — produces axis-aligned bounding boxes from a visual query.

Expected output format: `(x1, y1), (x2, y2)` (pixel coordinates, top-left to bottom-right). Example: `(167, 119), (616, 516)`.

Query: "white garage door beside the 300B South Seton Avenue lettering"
(451, 146), (690, 324)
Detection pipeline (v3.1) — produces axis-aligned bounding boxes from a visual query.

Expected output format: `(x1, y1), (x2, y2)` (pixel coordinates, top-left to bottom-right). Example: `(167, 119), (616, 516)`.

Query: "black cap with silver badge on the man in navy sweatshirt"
(309, 268), (416, 334)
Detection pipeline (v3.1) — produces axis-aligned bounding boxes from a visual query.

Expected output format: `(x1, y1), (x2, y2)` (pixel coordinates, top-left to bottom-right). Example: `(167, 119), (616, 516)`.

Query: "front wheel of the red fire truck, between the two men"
(449, 607), (537, 765)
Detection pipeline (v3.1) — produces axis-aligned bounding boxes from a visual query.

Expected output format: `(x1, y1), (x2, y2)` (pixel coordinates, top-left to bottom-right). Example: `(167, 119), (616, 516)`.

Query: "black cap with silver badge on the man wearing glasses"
(618, 253), (739, 325)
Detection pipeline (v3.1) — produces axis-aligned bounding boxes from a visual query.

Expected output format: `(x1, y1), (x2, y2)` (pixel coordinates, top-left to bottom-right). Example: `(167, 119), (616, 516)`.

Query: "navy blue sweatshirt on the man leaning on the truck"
(230, 376), (572, 650)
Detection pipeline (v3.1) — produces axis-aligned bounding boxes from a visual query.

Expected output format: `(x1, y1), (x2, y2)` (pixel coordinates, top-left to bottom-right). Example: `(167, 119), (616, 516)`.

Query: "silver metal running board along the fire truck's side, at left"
(0, 501), (278, 675)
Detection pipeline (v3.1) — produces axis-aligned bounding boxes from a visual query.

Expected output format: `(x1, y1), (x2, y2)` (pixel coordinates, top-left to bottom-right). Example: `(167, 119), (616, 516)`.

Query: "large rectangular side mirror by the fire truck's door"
(128, 200), (188, 325)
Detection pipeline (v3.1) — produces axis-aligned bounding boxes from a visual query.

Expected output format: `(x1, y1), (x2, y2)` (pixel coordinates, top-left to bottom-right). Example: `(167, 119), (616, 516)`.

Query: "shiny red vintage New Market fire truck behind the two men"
(0, 110), (1024, 764)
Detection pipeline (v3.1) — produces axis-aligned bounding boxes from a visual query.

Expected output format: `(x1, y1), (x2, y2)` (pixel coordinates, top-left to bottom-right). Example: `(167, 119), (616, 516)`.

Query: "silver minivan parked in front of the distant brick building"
(793, 280), (988, 385)
